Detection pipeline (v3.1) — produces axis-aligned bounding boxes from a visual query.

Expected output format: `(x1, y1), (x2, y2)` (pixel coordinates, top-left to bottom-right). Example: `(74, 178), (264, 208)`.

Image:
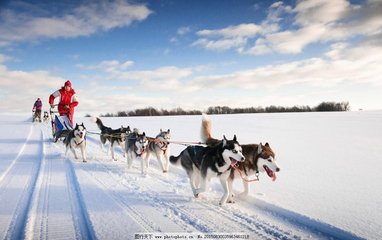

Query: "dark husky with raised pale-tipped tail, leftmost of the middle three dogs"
(90, 117), (131, 161)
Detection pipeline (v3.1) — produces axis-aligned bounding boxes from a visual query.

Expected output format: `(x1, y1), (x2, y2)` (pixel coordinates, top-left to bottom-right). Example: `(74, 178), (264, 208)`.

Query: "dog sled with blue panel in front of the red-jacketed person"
(49, 105), (73, 142)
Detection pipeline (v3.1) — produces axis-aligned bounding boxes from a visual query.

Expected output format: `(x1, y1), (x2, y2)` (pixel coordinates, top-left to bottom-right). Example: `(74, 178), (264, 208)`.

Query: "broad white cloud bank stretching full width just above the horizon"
(0, 37), (382, 115)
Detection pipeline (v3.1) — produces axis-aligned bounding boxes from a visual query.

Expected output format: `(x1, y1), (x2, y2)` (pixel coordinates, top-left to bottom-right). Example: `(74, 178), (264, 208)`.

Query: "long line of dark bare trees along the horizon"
(94, 102), (350, 117)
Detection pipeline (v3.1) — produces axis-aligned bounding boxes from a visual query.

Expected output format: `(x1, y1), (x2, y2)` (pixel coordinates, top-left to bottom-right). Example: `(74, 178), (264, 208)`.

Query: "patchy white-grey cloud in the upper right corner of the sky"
(193, 0), (382, 55)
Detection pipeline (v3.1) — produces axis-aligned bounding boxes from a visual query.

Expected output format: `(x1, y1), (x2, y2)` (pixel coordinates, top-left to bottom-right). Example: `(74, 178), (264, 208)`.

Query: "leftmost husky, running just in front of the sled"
(64, 123), (86, 162)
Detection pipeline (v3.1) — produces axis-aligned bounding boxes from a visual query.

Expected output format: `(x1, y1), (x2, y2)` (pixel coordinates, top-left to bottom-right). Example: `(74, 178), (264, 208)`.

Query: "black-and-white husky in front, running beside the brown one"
(170, 135), (244, 205)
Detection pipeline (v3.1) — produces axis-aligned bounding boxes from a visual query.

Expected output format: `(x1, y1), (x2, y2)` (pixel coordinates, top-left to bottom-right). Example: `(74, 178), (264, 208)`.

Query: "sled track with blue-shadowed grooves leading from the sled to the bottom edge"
(24, 125), (95, 239)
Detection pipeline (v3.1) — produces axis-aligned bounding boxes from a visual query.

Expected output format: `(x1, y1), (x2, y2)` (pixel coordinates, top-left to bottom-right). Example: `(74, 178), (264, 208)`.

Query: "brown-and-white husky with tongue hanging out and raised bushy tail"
(200, 114), (280, 202)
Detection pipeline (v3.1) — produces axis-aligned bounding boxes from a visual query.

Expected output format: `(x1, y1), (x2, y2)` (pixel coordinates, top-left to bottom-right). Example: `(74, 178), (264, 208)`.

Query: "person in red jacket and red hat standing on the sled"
(49, 80), (78, 126)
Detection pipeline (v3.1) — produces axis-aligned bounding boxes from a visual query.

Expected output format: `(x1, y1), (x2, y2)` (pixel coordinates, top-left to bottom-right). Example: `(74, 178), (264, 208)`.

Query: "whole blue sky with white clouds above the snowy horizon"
(0, 0), (382, 115)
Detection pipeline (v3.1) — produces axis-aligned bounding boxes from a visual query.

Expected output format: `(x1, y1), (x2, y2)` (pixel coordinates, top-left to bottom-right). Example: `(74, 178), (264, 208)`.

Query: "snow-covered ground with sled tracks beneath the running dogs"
(0, 111), (382, 239)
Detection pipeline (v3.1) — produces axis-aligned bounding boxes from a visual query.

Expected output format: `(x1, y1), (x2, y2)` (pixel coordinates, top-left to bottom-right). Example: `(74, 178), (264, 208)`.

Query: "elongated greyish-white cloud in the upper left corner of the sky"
(0, 0), (151, 46)
